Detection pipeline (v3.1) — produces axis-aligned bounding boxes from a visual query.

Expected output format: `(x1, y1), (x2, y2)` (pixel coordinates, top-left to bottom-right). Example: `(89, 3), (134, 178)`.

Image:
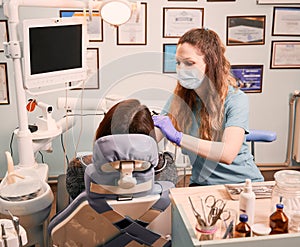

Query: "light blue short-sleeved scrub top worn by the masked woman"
(162, 86), (264, 185)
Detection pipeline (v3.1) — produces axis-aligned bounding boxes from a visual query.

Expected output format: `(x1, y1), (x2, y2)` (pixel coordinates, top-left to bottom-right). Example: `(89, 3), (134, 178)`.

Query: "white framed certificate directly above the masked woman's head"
(163, 7), (204, 38)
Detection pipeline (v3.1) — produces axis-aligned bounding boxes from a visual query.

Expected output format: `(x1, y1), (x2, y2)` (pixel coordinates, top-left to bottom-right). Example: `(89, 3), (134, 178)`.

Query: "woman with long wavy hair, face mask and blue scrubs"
(153, 28), (264, 186)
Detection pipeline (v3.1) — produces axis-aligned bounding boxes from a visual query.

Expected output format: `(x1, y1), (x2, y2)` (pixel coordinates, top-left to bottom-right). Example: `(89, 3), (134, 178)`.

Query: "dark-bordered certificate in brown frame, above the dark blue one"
(226, 15), (266, 46)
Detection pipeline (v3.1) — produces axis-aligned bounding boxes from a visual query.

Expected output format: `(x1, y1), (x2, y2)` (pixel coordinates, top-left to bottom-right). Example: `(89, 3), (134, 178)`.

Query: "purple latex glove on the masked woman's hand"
(152, 115), (182, 146)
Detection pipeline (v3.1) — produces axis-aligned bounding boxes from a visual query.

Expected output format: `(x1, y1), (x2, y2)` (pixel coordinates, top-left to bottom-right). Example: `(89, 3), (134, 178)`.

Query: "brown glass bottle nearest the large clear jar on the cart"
(270, 203), (289, 234)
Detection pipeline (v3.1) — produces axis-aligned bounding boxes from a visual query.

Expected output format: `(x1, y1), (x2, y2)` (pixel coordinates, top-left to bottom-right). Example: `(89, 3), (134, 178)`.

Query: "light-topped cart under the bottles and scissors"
(170, 182), (300, 247)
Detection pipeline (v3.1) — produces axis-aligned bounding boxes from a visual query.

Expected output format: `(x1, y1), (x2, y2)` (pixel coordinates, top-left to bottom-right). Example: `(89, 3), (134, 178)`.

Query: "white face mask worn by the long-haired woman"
(176, 68), (205, 89)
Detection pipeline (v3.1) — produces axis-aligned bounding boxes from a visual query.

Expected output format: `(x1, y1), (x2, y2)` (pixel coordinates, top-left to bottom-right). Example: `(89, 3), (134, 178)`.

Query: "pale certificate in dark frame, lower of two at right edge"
(270, 40), (300, 69)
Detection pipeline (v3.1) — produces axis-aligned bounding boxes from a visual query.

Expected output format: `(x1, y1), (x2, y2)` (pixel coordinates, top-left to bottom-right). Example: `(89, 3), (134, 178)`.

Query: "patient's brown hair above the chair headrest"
(95, 99), (156, 140)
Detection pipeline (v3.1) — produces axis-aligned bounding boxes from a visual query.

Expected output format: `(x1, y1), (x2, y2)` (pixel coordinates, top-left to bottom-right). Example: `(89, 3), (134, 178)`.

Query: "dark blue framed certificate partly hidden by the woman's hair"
(230, 64), (264, 93)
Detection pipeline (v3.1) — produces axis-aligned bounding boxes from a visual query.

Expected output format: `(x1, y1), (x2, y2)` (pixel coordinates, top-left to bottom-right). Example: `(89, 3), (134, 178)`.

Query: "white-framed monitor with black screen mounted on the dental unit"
(23, 18), (86, 89)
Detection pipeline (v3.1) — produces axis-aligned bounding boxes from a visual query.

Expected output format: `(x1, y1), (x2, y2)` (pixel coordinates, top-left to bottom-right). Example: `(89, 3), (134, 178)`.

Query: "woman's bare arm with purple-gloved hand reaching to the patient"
(153, 116), (245, 164)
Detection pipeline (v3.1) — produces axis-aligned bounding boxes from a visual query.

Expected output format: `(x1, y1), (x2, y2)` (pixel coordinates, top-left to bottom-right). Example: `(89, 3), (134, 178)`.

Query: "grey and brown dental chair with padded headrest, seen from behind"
(48, 134), (174, 247)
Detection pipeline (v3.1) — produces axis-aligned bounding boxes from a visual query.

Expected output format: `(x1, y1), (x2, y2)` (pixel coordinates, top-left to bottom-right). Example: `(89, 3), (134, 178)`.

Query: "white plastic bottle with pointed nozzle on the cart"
(240, 179), (255, 226)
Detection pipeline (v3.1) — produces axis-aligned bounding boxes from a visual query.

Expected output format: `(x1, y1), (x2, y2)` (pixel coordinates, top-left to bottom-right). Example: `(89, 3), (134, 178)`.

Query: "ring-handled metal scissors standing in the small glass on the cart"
(204, 195), (226, 225)
